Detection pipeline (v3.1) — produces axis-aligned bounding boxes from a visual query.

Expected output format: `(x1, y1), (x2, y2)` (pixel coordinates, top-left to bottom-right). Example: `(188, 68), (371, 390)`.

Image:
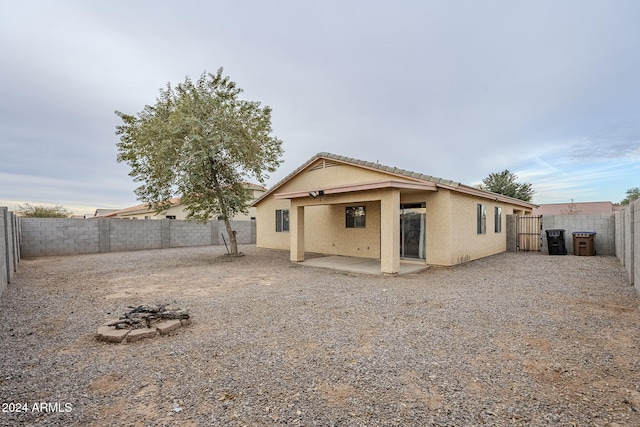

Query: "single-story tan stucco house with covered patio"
(253, 153), (535, 274)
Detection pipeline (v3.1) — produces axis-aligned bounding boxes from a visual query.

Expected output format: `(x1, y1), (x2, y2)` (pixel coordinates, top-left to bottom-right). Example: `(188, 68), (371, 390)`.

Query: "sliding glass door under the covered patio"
(400, 203), (427, 259)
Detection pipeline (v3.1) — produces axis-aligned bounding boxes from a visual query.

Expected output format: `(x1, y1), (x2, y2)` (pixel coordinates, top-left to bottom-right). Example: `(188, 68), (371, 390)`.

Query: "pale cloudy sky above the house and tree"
(0, 0), (640, 215)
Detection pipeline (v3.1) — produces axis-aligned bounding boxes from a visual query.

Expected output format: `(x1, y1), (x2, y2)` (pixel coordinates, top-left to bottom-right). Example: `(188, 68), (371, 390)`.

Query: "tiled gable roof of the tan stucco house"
(252, 152), (536, 209)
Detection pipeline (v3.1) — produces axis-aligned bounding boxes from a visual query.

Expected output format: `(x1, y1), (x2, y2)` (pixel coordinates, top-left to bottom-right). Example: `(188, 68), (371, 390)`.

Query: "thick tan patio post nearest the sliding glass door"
(380, 189), (400, 274)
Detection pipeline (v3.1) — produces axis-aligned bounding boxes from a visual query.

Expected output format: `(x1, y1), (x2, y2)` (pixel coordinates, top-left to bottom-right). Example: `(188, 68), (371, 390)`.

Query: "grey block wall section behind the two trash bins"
(541, 214), (616, 255)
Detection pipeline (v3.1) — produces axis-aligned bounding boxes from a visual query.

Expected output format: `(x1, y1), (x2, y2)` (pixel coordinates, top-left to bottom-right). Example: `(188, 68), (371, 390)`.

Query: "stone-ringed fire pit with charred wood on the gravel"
(96, 304), (191, 343)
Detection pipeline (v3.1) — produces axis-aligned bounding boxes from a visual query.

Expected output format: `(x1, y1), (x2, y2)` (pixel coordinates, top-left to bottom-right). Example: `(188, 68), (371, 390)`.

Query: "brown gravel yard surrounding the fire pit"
(0, 245), (640, 426)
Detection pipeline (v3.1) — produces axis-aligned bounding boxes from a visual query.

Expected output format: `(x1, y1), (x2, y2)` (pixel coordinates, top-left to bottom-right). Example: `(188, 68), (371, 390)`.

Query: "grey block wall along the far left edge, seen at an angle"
(0, 207), (20, 295)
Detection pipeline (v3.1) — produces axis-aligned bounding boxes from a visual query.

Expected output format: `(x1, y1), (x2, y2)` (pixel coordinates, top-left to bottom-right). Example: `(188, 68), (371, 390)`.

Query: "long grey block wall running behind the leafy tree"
(20, 218), (256, 257)
